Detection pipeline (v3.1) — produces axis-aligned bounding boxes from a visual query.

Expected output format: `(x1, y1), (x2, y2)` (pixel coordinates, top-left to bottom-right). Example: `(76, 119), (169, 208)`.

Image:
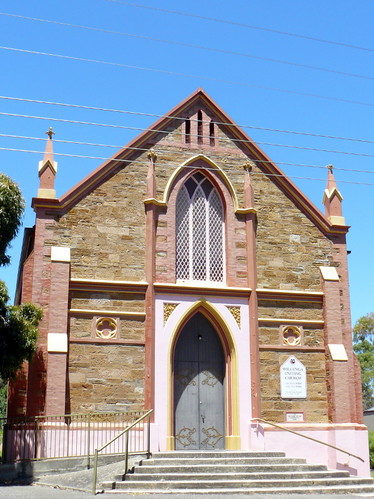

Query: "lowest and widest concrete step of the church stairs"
(103, 477), (374, 493)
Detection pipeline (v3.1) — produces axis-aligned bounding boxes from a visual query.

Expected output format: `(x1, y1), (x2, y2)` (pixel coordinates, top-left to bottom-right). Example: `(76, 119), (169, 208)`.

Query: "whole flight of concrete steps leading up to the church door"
(103, 451), (374, 497)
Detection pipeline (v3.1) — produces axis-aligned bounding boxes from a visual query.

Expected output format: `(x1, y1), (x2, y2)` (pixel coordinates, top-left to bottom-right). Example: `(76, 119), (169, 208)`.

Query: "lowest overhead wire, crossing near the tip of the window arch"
(0, 147), (374, 186)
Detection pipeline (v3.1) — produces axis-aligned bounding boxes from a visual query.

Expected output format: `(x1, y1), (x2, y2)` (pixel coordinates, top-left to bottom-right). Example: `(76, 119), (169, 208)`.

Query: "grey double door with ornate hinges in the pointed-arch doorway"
(174, 312), (225, 450)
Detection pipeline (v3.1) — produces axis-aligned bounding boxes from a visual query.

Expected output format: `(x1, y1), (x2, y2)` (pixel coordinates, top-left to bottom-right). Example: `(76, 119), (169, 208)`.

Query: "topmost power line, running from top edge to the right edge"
(101, 0), (374, 52)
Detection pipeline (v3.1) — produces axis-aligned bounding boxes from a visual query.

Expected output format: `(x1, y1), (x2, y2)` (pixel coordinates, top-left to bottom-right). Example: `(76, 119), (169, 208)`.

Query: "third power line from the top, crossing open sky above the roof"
(0, 46), (374, 107)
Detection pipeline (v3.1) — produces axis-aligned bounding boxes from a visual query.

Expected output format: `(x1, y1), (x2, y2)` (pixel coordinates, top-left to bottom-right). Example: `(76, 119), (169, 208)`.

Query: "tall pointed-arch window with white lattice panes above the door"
(176, 172), (224, 282)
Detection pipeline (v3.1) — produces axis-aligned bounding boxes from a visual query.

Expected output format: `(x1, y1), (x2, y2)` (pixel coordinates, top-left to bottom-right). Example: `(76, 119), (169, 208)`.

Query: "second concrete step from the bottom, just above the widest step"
(122, 471), (349, 482)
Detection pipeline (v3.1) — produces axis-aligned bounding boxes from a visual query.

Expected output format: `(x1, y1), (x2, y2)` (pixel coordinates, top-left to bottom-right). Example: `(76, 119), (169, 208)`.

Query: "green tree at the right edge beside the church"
(353, 312), (374, 410)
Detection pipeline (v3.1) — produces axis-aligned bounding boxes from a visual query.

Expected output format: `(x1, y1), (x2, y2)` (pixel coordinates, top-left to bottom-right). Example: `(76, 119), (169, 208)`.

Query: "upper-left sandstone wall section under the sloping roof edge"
(53, 162), (147, 281)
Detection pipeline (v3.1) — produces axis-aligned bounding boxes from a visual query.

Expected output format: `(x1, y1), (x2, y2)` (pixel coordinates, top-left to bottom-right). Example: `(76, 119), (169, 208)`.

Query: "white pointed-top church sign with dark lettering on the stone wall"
(280, 356), (306, 399)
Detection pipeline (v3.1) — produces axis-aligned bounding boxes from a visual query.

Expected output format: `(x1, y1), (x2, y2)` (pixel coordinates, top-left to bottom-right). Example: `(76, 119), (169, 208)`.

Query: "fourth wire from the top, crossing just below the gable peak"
(0, 95), (374, 144)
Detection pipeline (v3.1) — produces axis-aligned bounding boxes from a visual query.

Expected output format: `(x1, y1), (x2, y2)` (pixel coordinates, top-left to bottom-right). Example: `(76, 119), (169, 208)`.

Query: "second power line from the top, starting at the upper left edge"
(0, 12), (374, 80)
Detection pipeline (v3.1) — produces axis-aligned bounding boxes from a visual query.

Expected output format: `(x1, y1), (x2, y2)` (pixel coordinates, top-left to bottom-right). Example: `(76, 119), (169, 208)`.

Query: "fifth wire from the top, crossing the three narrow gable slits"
(0, 112), (374, 158)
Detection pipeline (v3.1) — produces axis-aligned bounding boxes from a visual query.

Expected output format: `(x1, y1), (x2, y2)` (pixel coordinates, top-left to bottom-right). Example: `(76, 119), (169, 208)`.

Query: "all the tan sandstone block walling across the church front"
(40, 109), (338, 421)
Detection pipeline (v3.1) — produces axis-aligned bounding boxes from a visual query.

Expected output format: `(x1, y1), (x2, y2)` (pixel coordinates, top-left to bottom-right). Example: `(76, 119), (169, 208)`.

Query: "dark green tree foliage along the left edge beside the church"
(0, 173), (42, 417)
